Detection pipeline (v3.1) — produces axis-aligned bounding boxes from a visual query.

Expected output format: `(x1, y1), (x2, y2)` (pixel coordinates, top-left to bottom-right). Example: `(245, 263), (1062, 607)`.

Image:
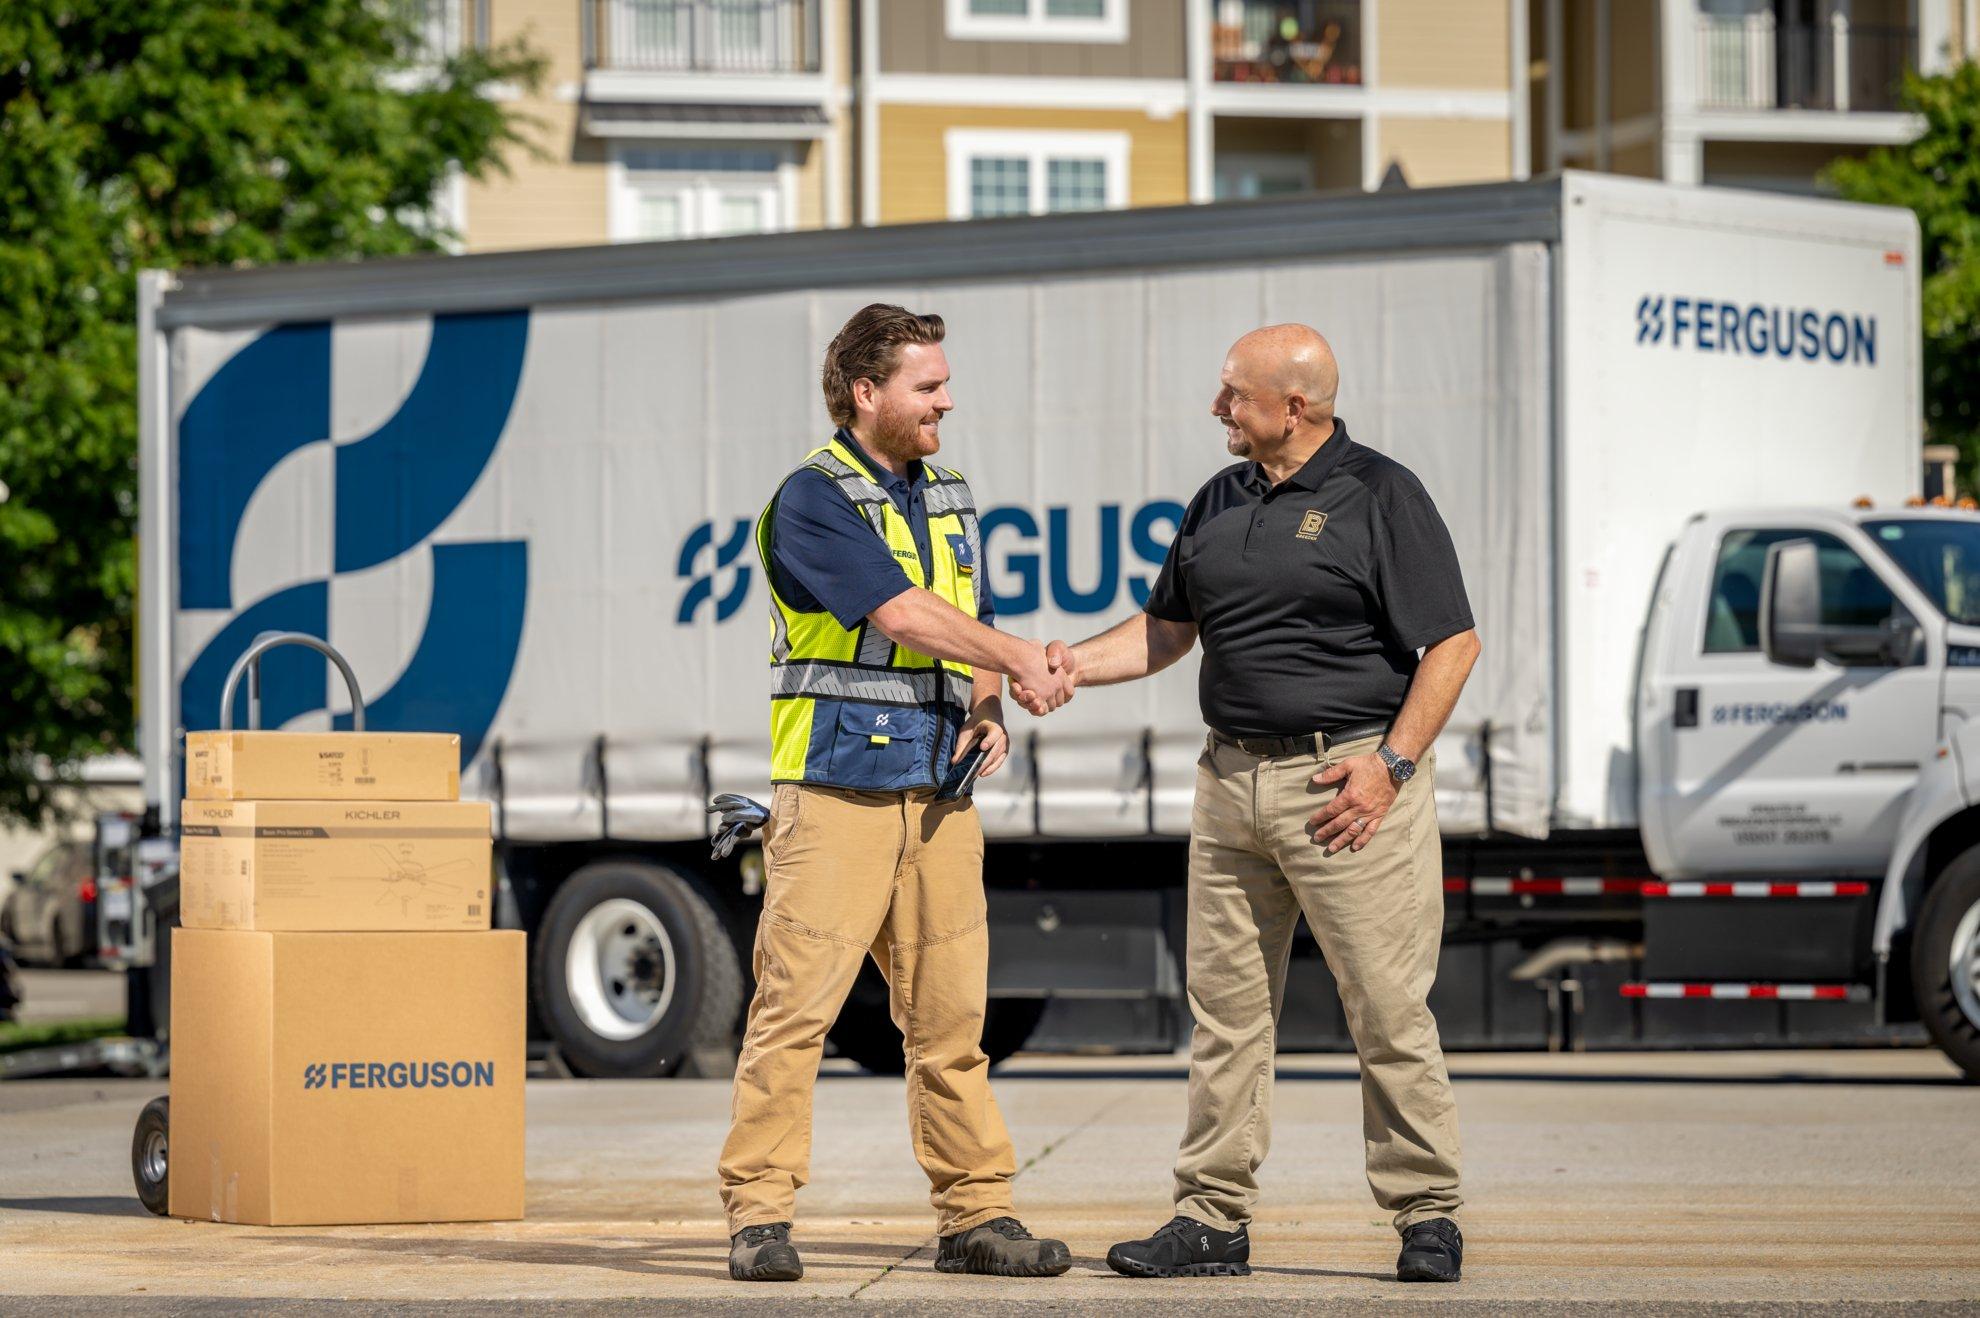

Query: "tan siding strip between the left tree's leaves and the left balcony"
(465, 0), (606, 251)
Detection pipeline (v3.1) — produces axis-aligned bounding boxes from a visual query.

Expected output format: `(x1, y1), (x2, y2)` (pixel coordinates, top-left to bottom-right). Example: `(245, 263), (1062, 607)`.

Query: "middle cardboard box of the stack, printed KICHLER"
(178, 801), (493, 932)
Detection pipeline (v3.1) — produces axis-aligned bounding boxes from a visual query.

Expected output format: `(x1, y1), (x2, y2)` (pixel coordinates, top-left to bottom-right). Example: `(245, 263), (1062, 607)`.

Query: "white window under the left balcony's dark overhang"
(612, 146), (788, 241)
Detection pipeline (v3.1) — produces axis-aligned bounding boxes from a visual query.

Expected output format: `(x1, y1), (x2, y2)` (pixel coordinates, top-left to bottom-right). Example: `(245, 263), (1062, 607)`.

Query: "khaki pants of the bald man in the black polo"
(1176, 736), (1461, 1231)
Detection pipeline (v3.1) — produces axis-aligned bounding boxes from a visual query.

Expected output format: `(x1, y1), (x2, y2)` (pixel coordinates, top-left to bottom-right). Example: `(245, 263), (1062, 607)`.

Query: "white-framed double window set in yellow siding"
(944, 129), (1129, 220)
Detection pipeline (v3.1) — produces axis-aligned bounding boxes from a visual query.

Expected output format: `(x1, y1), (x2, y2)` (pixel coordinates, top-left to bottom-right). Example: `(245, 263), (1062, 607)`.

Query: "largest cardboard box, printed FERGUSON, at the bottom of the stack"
(168, 928), (525, 1227)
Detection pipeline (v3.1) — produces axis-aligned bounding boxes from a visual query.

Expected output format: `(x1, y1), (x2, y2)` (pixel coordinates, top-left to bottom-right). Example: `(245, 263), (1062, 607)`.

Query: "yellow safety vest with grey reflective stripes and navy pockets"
(756, 435), (988, 792)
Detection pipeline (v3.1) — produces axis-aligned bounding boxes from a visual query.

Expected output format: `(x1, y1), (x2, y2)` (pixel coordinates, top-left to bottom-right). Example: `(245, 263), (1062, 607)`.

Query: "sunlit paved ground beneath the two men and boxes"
(0, 1051), (1980, 1316)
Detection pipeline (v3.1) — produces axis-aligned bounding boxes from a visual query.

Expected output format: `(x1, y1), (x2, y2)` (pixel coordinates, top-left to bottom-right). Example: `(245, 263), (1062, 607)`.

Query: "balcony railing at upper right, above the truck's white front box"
(1699, 12), (1919, 111)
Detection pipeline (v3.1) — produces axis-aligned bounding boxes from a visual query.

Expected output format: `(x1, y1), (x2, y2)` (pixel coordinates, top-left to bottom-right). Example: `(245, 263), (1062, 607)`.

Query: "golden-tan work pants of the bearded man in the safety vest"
(721, 784), (1016, 1235)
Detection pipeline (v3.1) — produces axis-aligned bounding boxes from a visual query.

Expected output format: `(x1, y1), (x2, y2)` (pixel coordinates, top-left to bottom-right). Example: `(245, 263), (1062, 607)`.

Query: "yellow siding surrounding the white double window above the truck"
(879, 105), (1190, 224)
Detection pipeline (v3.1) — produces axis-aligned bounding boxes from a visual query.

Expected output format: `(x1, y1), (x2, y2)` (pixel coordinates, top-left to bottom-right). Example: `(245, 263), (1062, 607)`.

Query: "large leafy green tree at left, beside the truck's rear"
(0, 0), (543, 821)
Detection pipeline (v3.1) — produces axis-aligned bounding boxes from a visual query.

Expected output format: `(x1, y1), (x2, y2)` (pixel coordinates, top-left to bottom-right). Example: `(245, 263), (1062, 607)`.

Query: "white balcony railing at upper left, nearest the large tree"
(582, 0), (820, 73)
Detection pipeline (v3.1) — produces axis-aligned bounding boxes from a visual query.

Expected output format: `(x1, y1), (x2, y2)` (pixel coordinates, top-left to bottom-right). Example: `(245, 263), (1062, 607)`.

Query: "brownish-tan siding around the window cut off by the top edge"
(879, 0), (1186, 77)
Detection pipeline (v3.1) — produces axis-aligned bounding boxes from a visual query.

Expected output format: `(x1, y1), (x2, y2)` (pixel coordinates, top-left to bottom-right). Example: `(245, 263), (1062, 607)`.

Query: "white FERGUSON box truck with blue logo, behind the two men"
(125, 174), (1980, 1075)
